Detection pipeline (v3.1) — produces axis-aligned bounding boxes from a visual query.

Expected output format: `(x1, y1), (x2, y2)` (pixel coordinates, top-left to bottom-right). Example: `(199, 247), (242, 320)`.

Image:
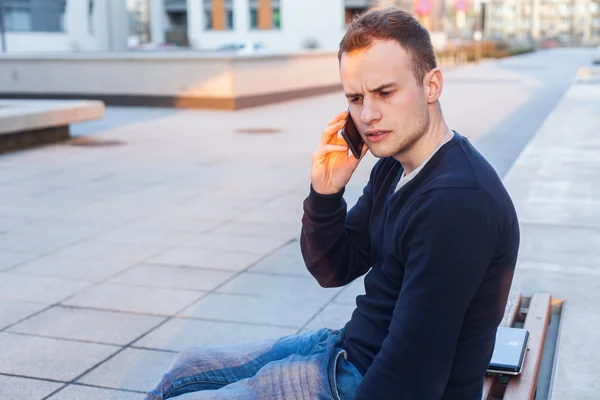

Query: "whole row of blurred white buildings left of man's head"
(0, 0), (375, 53)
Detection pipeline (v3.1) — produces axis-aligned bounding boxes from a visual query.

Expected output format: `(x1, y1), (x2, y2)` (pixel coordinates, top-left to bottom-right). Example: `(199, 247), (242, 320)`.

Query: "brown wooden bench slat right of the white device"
(504, 294), (552, 400)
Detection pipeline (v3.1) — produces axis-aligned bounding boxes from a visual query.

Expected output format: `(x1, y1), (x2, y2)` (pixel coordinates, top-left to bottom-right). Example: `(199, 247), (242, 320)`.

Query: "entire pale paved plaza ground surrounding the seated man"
(0, 49), (600, 400)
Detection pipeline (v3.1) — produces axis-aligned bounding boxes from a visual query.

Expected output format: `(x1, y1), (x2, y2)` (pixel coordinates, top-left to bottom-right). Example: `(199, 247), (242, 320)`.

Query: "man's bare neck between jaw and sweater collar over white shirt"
(394, 115), (450, 175)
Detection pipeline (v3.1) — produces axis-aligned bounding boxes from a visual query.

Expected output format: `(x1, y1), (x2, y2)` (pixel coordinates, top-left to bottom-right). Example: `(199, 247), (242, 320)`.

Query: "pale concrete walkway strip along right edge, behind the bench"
(505, 67), (600, 400)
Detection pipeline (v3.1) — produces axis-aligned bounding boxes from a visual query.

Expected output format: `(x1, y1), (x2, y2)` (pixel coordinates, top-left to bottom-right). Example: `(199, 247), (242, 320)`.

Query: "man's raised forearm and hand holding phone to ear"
(300, 111), (372, 287)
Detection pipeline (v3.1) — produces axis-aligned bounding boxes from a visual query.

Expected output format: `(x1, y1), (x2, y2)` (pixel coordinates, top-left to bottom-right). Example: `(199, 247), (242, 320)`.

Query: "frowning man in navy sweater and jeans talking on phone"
(149, 9), (519, 400)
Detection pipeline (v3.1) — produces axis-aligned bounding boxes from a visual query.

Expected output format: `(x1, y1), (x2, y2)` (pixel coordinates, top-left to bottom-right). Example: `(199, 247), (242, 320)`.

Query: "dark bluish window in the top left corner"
(3, 0), (66, 32)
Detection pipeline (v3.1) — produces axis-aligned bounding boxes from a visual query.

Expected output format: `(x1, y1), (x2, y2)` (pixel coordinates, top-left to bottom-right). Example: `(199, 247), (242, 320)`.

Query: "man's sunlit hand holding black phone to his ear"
(311, 111), (368, 194)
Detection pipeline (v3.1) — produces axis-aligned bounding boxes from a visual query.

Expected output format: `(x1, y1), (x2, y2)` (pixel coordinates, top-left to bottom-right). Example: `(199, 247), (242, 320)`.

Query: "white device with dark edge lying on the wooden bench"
(486, 327), (529, 376)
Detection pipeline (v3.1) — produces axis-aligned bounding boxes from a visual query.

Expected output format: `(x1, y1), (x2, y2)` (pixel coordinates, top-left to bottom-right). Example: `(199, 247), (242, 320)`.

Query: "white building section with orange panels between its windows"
(159, 0), (373, 51)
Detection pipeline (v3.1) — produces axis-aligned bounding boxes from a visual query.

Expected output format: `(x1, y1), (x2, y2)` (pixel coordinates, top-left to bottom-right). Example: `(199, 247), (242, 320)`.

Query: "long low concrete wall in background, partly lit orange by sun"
(0, 52), (340, 109)
